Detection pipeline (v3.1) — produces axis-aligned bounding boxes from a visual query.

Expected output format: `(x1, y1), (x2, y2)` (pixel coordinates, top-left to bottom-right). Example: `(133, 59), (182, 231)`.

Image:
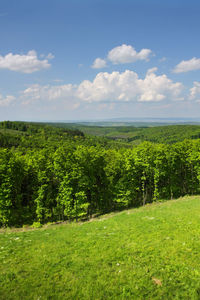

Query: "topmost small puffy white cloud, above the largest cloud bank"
(107, 44), (152, 64)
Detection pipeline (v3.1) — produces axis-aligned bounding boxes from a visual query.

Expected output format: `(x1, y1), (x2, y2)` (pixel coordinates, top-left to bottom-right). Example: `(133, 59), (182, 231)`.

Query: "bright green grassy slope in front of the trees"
(0, 196), (200, 300)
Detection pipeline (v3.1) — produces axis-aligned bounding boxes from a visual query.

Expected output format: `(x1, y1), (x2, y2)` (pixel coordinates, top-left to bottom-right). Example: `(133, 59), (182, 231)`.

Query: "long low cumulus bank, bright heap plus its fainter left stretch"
(21, 68), (183, 106)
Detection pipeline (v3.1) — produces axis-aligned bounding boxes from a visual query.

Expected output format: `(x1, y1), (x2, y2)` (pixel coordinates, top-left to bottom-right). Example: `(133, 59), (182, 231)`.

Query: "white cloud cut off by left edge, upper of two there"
(0, 50), (53, 73)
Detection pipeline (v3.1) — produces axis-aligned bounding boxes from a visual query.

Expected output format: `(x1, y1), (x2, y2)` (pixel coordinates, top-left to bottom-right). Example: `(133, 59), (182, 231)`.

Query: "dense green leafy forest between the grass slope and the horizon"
(0, 121), (200, 227)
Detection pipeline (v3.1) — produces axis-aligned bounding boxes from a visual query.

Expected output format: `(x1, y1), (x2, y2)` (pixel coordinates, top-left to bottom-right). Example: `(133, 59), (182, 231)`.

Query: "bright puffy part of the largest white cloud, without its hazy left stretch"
(76, 68), (183, 102)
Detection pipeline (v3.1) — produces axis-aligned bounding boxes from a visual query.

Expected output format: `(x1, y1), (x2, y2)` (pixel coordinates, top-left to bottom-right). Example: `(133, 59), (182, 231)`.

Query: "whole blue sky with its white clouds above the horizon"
(0, 0), (200, 121)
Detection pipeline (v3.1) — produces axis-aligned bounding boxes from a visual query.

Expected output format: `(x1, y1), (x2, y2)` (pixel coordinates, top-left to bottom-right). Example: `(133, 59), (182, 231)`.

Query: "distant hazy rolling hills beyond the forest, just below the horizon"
(46, 123), (200, 144)
